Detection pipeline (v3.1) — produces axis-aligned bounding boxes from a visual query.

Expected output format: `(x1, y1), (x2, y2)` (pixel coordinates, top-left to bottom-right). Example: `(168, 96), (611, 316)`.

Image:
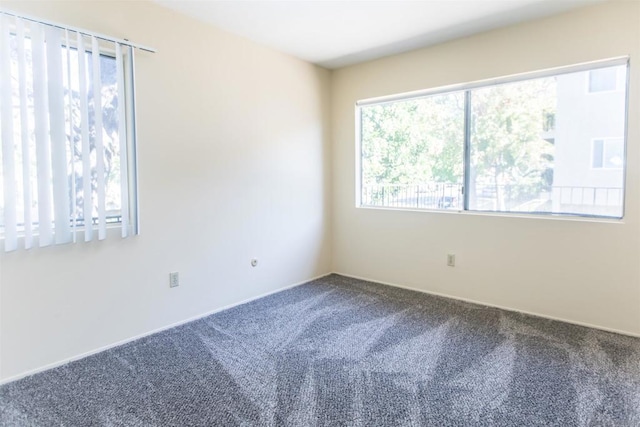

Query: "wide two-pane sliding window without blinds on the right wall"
(357, 59), (627, 218)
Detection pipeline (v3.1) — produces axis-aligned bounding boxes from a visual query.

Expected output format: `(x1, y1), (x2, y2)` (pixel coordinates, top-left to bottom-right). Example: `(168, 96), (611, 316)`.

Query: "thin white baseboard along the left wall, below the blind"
(0, 273), (333, 385)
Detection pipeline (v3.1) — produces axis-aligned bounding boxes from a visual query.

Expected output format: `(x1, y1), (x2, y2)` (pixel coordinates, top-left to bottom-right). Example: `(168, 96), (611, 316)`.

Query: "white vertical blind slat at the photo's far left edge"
(0, 15), (18, 251)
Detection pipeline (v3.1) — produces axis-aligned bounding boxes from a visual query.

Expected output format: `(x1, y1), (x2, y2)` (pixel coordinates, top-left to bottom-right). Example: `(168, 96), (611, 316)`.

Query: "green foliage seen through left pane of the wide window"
(362, 93), (464, 185)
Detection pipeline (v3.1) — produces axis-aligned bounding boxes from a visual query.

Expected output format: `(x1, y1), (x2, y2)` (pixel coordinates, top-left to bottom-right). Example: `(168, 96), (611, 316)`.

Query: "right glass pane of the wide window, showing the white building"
(469, 66), (626, 217)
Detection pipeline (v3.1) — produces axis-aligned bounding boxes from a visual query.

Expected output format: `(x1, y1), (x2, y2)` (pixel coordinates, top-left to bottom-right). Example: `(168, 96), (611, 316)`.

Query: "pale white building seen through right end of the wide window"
(551, 65), (627, 218)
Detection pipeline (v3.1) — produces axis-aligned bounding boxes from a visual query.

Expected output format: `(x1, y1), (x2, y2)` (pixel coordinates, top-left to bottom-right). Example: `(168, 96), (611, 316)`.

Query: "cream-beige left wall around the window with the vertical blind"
(0, 1), (330, 379)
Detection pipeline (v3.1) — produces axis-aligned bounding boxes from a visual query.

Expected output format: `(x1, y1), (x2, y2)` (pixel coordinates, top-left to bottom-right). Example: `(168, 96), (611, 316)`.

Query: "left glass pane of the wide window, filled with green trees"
(360, 92), (464, 209)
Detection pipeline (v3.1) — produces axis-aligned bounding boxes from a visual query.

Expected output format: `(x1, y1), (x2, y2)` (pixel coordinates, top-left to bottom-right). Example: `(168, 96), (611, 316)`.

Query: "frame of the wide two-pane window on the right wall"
(354, 56), (630, 222)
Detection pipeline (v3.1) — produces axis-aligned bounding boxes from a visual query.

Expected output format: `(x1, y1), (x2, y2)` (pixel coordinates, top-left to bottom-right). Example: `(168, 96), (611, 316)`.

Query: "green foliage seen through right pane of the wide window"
(471, 78), (556, 202)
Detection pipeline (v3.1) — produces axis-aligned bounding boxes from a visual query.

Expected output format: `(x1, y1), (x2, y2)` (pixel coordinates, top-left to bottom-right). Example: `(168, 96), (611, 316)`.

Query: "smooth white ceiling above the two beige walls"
(154, 0), (604, 68)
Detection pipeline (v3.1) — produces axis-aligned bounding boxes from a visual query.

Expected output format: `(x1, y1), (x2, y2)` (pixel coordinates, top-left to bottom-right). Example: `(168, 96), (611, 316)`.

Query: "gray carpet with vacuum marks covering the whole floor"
(0, 275), (640, 426)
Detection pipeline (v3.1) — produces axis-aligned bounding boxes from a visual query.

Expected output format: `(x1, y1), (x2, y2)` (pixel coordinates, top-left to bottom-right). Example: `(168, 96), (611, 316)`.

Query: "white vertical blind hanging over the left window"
(0, 11), (149, 251)
